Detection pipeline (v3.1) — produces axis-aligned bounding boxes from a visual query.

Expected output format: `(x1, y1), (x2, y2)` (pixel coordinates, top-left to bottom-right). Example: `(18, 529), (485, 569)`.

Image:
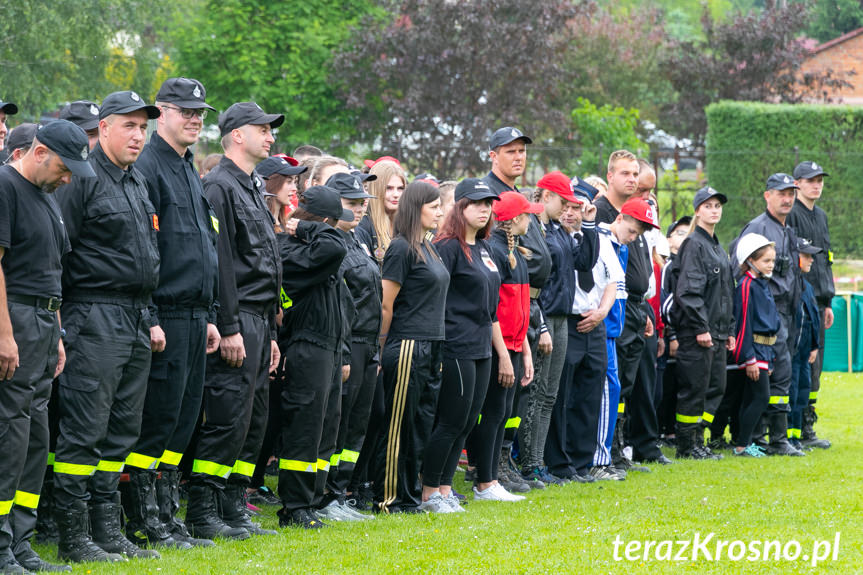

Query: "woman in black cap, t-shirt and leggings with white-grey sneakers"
(420, 178), (500, 513)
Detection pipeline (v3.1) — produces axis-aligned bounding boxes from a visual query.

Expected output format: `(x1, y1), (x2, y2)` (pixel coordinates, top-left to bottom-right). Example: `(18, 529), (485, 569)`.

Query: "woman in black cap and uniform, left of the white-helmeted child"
(671, 187), (734, 459)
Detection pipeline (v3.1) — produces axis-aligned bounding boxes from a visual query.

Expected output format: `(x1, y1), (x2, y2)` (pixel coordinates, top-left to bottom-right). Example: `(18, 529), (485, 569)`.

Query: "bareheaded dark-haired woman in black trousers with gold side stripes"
(374, 182), (449, 513)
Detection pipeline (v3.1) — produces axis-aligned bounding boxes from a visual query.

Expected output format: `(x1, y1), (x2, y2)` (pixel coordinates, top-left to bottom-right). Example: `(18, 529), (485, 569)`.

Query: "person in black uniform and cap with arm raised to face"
(279, 186), (354, 529)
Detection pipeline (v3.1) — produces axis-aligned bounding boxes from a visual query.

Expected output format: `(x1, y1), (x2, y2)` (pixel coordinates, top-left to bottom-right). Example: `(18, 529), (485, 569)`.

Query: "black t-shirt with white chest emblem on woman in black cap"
(435, 239), (500, 359)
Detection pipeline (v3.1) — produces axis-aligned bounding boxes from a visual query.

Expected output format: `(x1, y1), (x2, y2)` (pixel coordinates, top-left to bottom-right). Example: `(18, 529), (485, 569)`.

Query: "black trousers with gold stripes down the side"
(374, 338), (443, 513)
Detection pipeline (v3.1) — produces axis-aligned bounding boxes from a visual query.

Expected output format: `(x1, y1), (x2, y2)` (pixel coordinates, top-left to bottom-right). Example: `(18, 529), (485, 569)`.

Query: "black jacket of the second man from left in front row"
(56, 145), (159, 312)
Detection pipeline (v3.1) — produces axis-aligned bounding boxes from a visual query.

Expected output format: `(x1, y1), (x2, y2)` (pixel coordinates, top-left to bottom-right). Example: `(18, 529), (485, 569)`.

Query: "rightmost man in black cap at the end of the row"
(788, 161), (836, 449)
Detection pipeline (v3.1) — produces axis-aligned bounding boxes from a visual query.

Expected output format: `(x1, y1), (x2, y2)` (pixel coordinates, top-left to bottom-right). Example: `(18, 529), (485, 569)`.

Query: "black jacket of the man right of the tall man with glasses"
(203, 156), (282, 339)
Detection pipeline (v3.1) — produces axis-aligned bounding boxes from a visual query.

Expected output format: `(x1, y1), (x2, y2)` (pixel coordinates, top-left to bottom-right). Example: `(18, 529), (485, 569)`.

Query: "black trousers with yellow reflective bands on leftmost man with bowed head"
(0, 302), (60, 554)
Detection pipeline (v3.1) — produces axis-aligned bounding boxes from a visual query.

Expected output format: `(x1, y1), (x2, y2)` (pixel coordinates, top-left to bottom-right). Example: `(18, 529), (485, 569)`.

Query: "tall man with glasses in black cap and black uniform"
(126, 78), (219, 549)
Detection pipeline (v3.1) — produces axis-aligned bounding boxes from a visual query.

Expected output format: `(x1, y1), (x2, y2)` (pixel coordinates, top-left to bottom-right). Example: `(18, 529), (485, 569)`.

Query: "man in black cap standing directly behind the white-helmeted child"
(728, 173), (802, 456)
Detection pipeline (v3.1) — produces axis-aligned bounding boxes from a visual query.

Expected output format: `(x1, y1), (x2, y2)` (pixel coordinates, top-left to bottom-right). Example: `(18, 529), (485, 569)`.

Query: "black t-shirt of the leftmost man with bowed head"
(0, 166), (71, 297)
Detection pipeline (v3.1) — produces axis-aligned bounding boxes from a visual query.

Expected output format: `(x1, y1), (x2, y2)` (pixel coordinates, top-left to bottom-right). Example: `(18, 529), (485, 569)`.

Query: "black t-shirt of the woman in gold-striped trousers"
(381, 236), (449, 341)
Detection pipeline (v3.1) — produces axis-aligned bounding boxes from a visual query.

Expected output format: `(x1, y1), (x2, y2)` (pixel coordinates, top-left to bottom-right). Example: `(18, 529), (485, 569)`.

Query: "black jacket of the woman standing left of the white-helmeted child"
(671, 227), (734, 341)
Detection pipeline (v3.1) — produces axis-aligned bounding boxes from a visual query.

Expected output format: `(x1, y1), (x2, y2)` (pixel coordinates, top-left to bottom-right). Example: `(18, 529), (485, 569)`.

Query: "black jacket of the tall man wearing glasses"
(135, 132), (219, 324)
